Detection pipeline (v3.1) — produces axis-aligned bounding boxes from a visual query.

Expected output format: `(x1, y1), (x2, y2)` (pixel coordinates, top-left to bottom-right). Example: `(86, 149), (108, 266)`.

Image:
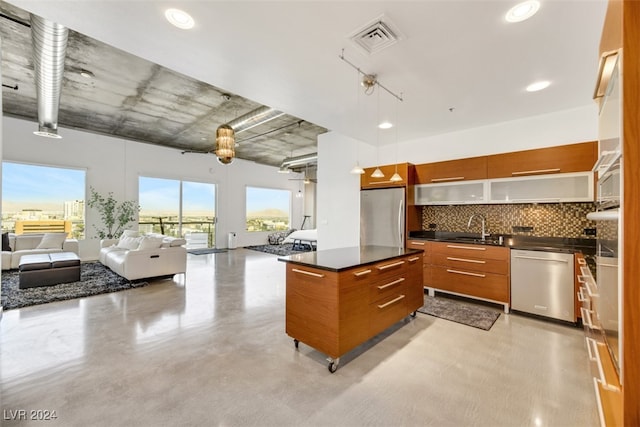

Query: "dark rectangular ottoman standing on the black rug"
(18, 252), (80, 289)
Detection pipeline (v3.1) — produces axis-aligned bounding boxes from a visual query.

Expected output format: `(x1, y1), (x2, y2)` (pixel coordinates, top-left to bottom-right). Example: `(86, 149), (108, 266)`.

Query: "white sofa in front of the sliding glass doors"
(99, 232), (187, 280)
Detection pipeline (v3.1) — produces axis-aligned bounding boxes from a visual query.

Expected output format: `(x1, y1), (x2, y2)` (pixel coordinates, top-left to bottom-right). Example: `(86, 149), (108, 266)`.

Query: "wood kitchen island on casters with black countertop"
(278, 246), (424, 372)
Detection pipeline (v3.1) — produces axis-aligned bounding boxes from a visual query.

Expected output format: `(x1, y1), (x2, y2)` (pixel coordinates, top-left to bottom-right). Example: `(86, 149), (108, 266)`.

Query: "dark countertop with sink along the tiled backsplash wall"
(409, 230), (596, 255)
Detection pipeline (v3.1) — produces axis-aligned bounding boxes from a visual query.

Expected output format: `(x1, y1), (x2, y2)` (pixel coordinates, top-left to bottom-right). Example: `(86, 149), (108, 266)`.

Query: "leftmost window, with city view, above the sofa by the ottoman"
(2, 162), (86, 239)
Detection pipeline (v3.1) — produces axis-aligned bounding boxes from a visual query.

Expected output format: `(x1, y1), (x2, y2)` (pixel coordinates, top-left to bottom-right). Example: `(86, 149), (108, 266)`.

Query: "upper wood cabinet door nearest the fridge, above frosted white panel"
(415, 156), (487, 184)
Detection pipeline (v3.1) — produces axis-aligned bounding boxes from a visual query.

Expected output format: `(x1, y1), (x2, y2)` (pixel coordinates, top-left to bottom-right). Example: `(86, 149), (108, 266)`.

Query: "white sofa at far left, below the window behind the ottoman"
(2, 233), (79, 270)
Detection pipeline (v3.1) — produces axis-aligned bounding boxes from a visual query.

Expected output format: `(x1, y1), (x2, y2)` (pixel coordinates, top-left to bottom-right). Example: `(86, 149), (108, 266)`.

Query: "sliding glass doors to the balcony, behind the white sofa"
(139, 176), (216, 248)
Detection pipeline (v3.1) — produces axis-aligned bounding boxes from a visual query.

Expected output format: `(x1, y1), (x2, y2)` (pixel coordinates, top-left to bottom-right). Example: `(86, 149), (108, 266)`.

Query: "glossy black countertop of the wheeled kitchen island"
(278, 246), (422, 272)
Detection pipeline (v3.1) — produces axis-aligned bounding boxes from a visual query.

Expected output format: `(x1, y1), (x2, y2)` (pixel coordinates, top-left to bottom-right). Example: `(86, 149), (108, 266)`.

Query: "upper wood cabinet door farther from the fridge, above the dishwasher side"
(487, 141), (598, 178)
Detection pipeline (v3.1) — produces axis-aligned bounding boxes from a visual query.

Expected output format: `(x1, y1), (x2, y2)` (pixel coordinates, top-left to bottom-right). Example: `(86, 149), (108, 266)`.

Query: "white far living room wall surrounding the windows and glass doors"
(2, 117), (303, 259)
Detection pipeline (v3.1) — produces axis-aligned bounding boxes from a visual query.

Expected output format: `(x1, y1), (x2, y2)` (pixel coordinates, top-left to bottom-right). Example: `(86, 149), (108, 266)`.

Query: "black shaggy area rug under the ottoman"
(2, 262), (148, 310)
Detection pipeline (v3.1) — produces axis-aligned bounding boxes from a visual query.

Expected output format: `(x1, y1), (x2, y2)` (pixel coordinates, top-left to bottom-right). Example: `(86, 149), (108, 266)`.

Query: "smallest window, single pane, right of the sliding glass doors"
(247, 187), (291, 231)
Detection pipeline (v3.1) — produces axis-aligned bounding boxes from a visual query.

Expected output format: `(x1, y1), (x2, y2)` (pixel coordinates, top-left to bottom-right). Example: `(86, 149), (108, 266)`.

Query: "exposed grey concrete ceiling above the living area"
(0, 2), (326, 166)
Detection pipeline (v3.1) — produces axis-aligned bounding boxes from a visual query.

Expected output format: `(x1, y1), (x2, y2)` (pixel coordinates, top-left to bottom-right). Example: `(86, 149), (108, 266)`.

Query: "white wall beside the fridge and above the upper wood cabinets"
(317, 104), (598, 249)
